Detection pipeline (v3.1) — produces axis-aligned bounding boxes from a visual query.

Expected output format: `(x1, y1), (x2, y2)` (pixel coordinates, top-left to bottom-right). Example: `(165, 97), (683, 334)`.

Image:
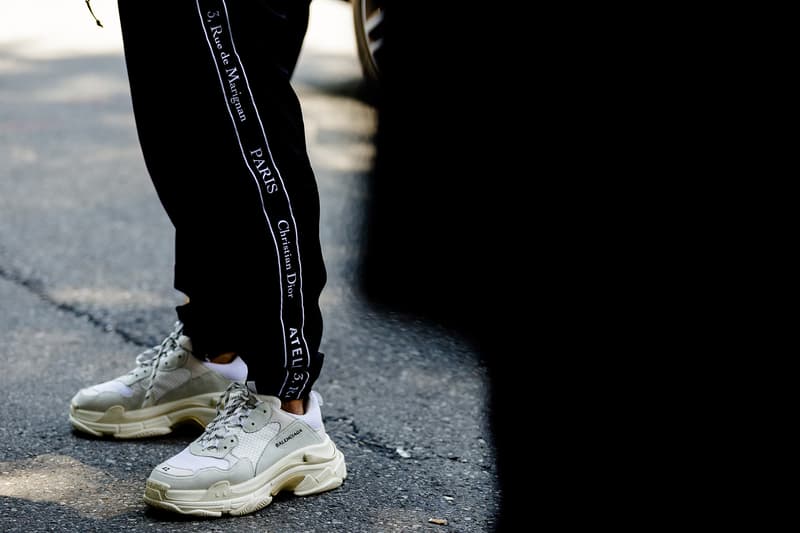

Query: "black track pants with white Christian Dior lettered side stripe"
(119, 0), (326, 399)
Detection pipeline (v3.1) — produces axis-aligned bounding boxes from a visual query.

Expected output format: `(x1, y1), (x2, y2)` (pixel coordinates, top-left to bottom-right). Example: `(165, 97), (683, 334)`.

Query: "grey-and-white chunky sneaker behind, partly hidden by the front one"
(69, 322), (241, 439)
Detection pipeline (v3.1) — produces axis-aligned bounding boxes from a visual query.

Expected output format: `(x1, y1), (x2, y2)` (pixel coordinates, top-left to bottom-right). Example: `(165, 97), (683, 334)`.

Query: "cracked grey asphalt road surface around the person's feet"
(0, 0), (498, 532)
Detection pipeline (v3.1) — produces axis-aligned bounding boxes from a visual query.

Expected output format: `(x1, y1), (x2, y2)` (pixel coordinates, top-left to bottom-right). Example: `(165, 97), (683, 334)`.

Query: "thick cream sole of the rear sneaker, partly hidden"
(69, 392), (221, 439)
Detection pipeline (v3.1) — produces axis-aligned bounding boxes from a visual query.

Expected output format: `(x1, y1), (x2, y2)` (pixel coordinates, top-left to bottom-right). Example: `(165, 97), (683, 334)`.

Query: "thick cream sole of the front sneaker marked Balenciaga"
(144, 438), (347, 517)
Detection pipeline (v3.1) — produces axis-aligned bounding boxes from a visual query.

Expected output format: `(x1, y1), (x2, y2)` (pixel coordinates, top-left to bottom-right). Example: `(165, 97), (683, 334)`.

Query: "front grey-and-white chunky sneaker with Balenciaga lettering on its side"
(144, 383), (347, 517)
